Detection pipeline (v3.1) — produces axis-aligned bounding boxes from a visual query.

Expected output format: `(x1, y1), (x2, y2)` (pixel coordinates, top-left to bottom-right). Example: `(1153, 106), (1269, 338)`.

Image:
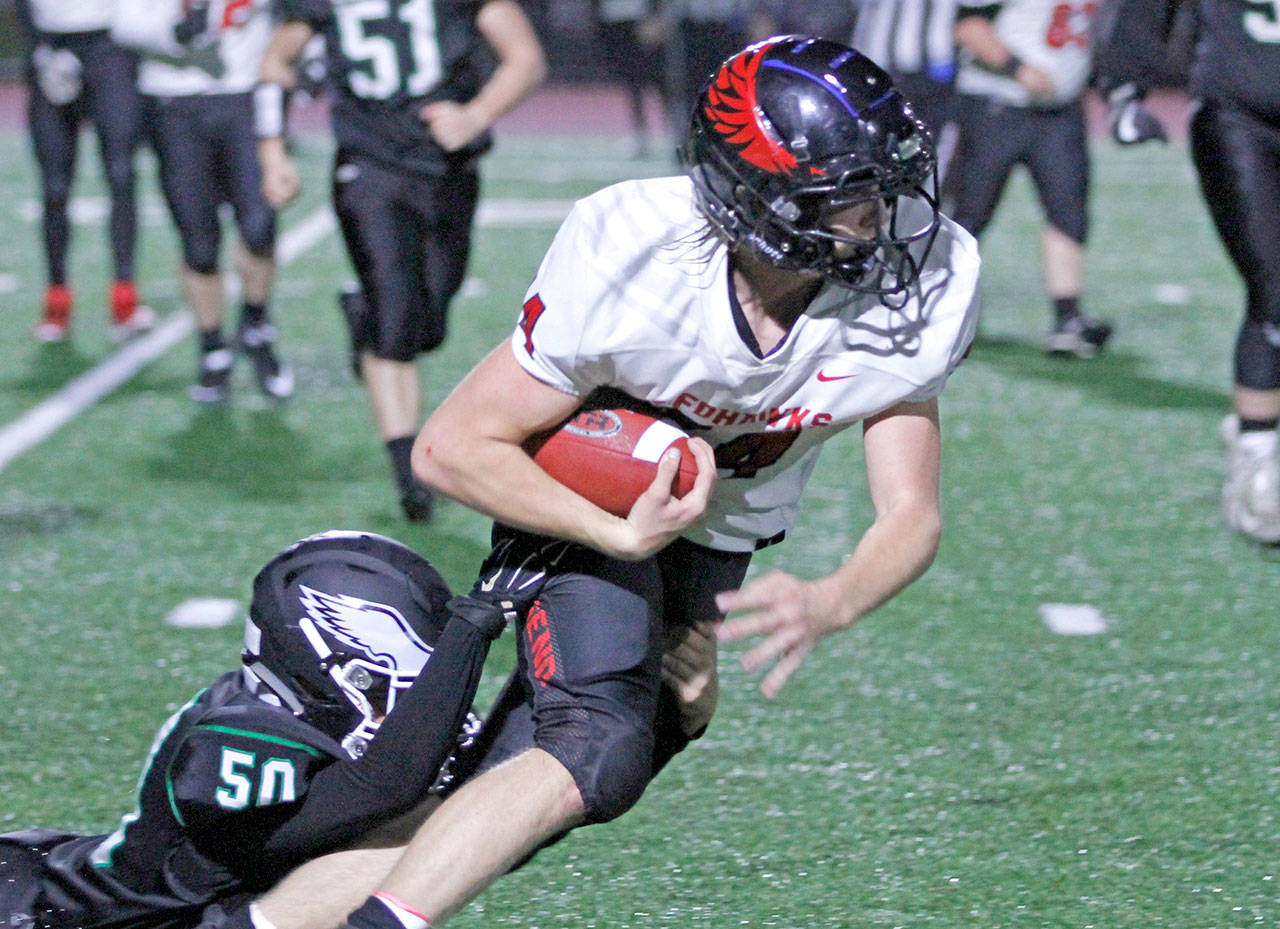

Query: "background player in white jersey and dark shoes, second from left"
(113, 0), (293, 403)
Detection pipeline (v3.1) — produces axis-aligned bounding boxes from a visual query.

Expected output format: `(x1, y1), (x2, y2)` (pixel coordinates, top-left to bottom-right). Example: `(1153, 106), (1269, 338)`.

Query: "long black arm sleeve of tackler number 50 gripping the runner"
(264, 615), (492, 862)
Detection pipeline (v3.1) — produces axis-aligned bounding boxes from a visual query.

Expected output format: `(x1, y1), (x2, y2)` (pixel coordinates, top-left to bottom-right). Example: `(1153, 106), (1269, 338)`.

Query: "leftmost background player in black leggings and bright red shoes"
(17, 0), (155, 342)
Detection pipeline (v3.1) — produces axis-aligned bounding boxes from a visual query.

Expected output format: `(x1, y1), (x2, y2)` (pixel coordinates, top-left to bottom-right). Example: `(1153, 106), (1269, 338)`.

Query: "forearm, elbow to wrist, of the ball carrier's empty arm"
(817, 500), (942, 626)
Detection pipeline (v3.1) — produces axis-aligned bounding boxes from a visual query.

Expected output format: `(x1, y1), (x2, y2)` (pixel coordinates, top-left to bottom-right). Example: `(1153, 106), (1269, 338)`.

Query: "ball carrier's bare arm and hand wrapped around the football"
(413, 343), (716, 558)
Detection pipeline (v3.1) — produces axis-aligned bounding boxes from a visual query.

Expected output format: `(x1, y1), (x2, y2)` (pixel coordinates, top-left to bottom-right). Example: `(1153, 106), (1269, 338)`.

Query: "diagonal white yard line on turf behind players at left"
(0, 209), (334, 471)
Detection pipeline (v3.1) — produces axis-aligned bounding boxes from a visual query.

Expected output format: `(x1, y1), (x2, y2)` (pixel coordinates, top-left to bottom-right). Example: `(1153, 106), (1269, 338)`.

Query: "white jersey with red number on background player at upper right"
(956, 0), (1098, 106)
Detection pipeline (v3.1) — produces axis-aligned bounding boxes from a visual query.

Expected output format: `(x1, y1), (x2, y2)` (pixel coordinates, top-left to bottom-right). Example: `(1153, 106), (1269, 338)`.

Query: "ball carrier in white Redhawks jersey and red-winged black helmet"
(230, 36), (979, 929)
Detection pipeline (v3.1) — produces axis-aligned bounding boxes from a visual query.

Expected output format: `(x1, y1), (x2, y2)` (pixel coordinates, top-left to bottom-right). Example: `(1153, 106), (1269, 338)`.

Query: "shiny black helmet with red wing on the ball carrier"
(681, 36), (938, 296)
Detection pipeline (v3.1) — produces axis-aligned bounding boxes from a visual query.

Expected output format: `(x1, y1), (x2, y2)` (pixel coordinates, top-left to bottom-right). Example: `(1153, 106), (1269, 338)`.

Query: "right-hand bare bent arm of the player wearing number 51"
(421, 0), (547, 151)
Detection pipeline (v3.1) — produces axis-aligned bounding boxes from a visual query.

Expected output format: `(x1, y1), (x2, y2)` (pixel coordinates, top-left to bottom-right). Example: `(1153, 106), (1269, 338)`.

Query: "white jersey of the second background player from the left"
(111, 0), (275, 97)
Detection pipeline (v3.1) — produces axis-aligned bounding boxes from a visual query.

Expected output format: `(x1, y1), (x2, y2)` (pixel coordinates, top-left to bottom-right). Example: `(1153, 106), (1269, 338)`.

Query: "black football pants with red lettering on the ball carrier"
(468, 527), (751, 824)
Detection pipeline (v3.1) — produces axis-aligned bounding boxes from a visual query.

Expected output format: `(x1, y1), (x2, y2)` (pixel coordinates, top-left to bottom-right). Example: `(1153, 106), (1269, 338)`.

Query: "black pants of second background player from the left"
(147, 93), (275, 274)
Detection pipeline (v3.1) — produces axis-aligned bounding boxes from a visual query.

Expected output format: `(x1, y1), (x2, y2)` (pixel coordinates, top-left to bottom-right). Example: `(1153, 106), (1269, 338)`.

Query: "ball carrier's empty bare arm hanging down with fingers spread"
(717, 401), (942, 697)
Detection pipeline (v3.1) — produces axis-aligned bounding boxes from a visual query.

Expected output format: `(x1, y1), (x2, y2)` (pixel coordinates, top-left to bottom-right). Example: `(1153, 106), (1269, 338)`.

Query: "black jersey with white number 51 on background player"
(282, 0), (492, 174)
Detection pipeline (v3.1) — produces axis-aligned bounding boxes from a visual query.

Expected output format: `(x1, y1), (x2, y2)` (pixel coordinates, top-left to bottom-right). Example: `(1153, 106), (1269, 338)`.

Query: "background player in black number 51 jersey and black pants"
(256, 0), (547, 520)
